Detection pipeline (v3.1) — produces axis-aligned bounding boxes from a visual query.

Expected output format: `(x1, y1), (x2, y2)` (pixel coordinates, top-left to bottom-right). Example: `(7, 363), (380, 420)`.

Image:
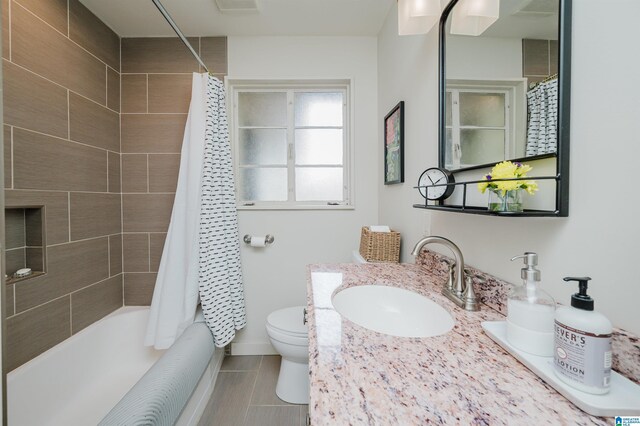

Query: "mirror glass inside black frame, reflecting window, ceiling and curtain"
(440, 0), (559, 170)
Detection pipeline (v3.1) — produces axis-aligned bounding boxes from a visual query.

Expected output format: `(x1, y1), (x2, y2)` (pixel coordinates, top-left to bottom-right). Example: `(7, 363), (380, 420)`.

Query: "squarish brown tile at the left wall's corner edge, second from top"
(69, 93), (120, 152)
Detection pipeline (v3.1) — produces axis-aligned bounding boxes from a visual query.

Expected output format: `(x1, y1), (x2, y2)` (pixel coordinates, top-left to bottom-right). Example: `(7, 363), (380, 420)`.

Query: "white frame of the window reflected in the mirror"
(445, 79), (526, 169)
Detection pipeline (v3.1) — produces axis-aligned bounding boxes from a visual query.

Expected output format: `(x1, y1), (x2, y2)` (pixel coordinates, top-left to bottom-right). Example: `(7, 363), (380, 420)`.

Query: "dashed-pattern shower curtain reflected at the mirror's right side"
(526, 78), (558, 157)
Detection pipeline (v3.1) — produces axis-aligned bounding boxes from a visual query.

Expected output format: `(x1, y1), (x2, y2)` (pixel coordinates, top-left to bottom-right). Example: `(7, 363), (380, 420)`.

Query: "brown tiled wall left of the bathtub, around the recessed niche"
(2, 0), (123, 370)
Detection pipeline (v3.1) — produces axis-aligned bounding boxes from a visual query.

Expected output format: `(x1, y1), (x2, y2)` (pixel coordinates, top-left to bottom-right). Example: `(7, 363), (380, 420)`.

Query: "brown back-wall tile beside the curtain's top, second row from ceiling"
(149, 74), (193, 114)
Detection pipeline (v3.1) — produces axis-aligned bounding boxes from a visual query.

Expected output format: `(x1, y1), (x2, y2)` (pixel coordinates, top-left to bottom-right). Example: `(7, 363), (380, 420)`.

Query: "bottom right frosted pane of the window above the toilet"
(296, 167), (344, 201)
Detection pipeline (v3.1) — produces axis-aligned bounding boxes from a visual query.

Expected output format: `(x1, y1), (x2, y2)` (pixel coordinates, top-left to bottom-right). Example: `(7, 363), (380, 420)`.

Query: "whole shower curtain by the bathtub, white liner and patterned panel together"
(144, 73), (246, 349)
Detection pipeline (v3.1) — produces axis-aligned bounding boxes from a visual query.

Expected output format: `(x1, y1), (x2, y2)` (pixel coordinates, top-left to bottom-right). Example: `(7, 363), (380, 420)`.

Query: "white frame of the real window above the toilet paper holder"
(226, 79), (355, 210)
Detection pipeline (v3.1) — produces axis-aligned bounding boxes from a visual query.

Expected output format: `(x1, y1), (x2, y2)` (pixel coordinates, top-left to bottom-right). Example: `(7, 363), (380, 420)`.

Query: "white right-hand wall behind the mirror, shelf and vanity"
(378, 0), (640, 334)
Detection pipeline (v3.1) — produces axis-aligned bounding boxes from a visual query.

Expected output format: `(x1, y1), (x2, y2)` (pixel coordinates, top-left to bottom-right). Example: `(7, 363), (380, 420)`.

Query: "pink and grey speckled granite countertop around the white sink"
(307, 264), (607, 426)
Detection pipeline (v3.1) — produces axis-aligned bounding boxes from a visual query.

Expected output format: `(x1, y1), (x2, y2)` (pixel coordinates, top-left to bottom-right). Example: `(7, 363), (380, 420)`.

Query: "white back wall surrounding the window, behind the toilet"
(228, 37), (382, 354)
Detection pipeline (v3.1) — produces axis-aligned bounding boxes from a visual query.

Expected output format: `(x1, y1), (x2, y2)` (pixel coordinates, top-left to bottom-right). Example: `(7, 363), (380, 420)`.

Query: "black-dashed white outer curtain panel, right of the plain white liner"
(199, 76), (246, 347)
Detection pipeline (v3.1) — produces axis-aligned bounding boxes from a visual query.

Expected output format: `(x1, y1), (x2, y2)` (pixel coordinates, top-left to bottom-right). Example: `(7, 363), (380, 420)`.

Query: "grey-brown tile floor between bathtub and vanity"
(198, 355), (308, 426)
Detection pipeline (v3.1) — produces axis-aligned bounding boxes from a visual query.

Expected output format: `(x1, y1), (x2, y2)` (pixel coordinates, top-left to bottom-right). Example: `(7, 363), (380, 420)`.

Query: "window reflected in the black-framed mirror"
(445, 82), (524, 169)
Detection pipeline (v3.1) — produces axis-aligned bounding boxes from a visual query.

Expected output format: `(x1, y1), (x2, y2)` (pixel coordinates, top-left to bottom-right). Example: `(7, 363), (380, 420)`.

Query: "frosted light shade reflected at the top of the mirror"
(451, 0), (500, 36)
